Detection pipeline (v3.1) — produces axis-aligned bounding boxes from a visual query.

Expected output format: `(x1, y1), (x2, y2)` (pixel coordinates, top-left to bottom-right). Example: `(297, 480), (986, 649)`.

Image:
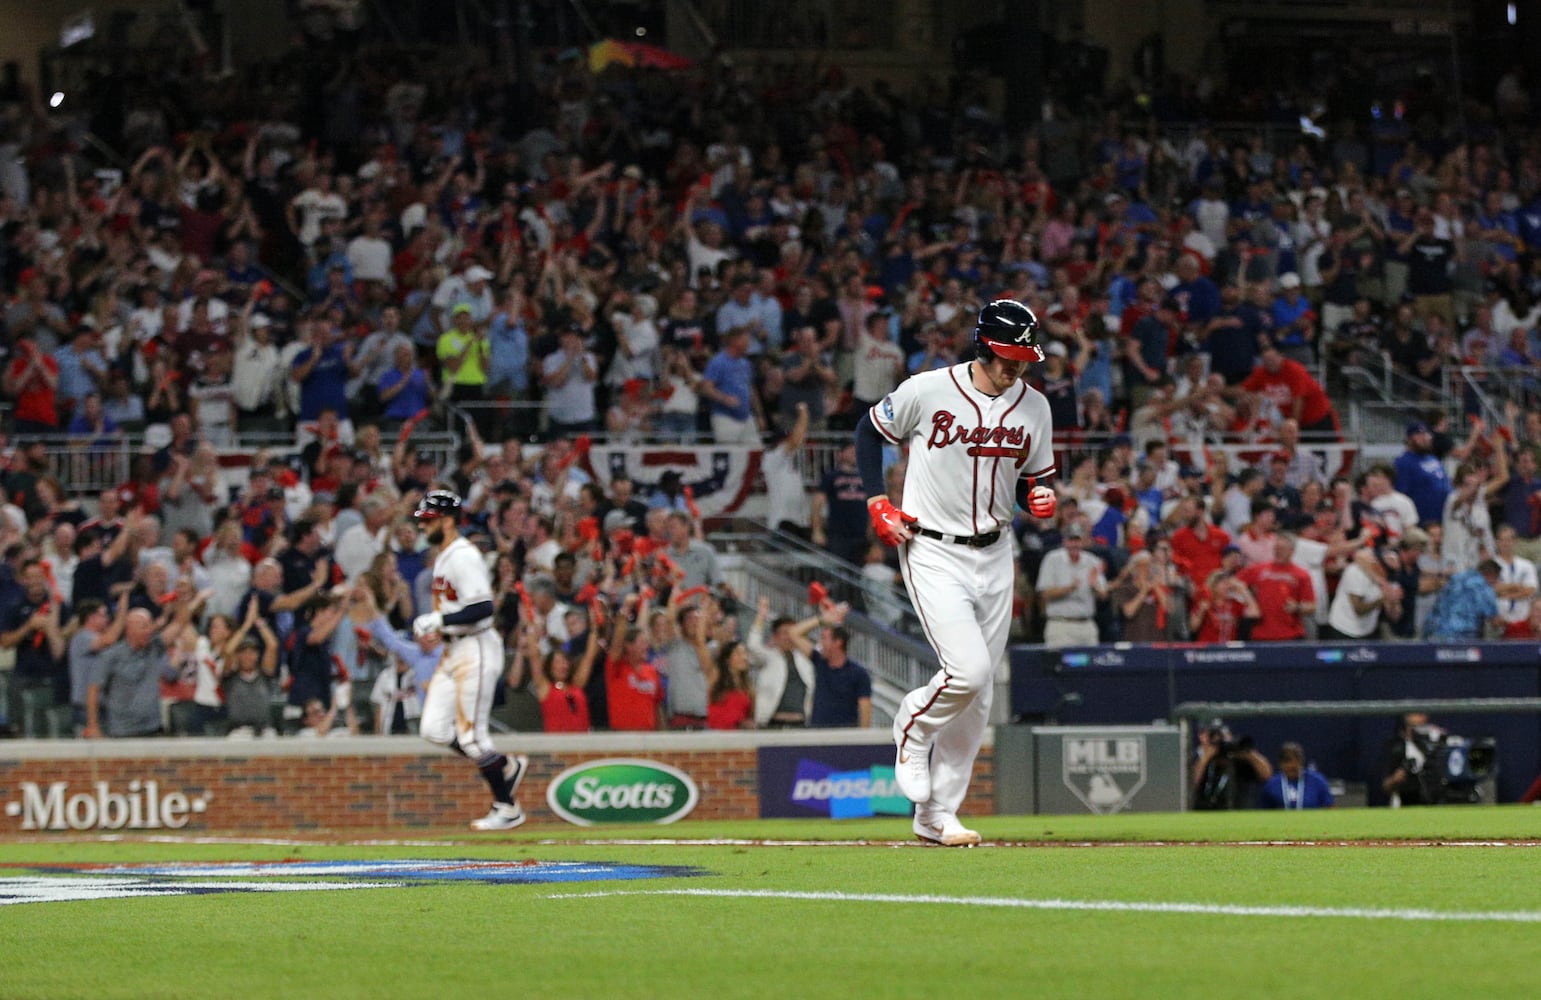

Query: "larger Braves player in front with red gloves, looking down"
(857, 299), (1056, 847)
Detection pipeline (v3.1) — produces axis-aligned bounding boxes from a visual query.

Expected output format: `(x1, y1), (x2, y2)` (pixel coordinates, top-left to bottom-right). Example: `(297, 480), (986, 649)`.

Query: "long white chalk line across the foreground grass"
(546, 889), (1541, 923)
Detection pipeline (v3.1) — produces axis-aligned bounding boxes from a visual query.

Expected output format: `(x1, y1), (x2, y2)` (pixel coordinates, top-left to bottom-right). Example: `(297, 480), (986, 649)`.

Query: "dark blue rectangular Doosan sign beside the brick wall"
(760, 744), (914, 820)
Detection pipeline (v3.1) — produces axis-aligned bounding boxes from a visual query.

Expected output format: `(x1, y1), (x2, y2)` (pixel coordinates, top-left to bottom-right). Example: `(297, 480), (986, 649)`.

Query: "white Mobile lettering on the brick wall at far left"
(5, 781), (211, 831)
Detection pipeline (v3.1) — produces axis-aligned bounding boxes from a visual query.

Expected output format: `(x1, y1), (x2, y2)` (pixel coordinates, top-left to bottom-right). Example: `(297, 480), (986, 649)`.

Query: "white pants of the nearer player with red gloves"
(894, 533), (1016, 815)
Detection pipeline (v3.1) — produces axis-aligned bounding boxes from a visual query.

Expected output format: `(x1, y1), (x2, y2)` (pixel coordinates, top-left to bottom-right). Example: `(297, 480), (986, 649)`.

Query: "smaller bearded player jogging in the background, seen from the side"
(411, 490), (530, 831)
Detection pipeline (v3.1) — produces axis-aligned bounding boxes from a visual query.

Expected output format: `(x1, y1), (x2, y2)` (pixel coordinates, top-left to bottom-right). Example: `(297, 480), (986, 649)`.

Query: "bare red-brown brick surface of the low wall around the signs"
(0, 747), (994, 834)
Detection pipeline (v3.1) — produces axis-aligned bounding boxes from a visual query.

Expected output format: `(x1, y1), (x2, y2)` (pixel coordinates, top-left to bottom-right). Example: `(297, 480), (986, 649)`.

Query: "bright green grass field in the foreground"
(0, 806), (1541, 1000)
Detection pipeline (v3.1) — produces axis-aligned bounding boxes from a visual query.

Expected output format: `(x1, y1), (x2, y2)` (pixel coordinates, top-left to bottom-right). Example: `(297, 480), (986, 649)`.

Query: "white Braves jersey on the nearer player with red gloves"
(871, 362), (1054, 535)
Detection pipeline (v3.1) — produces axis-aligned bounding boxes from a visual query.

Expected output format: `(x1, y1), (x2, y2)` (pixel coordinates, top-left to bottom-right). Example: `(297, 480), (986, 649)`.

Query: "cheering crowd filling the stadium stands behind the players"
(0, 27), (1541, 737)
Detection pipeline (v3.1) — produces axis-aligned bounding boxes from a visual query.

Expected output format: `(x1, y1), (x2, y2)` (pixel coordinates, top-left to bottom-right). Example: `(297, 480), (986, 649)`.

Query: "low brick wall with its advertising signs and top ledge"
(0, 729), (994, 835)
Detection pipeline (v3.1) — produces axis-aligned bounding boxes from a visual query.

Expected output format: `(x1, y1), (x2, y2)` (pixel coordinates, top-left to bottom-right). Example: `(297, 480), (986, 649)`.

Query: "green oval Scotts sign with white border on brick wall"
(546, 758), (700, 826)
